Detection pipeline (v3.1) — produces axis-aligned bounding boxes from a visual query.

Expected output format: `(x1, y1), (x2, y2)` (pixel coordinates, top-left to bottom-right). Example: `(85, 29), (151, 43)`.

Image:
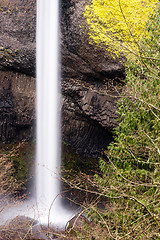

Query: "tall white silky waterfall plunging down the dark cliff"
(36, 0), (71, 225)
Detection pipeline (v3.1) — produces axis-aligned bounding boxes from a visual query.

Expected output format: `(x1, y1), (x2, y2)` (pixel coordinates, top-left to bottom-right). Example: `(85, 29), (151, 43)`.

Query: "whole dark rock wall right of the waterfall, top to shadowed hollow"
(61, 0), (124, 156)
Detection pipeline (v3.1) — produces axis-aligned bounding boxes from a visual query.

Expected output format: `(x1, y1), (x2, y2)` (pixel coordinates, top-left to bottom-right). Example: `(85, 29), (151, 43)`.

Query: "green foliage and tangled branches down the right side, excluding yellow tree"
(80, 1), (160, 240)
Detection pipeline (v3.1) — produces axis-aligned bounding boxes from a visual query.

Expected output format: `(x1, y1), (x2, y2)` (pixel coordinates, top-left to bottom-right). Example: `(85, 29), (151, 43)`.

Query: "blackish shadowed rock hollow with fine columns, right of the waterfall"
(62, 101), (112, 157)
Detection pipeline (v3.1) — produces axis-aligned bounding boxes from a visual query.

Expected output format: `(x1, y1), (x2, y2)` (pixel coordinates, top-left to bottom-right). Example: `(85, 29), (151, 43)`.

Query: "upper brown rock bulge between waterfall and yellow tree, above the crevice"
(61, 0), (124, 81)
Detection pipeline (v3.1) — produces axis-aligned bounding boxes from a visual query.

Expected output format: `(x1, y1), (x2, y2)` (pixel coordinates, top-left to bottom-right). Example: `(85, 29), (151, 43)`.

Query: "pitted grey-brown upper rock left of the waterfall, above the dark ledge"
(0, 0), (36, 76)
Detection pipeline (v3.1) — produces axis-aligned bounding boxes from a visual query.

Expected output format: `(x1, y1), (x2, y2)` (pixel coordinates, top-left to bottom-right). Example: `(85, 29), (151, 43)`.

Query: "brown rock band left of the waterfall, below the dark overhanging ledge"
(0, 71), (35, 142)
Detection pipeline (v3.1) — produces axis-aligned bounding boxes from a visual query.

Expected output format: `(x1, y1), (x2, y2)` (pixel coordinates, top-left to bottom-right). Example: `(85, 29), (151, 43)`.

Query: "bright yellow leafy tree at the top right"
(84, 0), (158, 57)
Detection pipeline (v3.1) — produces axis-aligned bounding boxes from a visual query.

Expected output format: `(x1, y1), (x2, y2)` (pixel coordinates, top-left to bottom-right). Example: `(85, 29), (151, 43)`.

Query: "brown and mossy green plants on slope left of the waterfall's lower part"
(0, 141), (35, 199)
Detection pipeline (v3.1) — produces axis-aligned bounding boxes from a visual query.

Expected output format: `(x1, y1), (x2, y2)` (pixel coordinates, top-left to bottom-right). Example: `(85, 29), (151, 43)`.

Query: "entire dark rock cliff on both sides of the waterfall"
(0, 0), (124, 156)
